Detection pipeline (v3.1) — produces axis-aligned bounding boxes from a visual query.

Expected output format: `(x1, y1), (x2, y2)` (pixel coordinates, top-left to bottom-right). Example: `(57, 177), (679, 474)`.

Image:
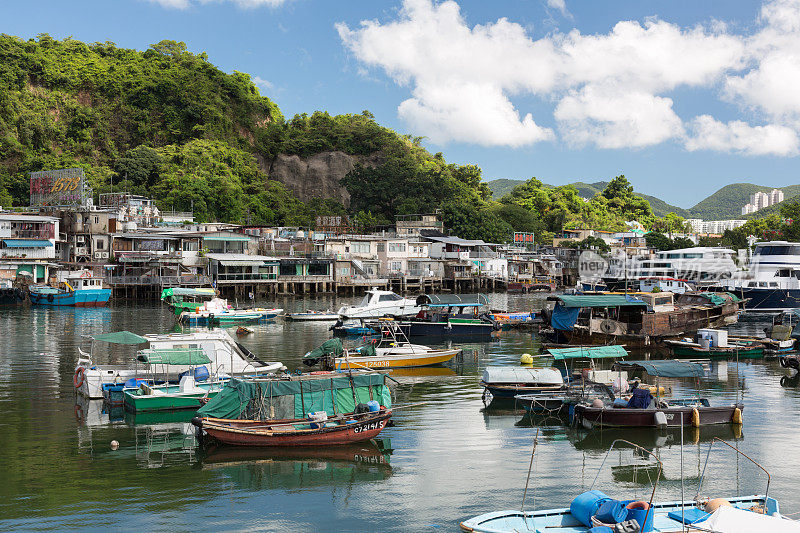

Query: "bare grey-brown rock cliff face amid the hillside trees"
(269, 151), (383, 206)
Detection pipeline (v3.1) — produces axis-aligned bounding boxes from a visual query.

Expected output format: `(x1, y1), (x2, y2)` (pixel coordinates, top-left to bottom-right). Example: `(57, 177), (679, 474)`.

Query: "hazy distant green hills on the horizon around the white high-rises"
(487, 179), (800, 220)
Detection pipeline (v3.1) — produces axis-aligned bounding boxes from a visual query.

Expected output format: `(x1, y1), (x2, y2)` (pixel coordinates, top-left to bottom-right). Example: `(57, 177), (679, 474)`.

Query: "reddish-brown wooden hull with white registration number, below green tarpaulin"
(192, 410), (392, 446)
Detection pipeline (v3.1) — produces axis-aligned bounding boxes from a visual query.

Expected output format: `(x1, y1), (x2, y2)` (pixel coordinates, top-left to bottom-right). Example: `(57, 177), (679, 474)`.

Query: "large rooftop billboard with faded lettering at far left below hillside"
(30, 168), (92, 207)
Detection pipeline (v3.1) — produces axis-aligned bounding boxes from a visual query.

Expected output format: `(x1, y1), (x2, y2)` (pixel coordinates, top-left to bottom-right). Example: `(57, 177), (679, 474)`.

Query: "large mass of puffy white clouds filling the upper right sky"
(336, 0), (800, 155)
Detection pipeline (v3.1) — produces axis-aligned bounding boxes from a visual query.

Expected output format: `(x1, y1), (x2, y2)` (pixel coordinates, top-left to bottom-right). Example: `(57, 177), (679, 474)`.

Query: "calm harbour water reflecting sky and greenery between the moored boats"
(0, 294), (800, 531)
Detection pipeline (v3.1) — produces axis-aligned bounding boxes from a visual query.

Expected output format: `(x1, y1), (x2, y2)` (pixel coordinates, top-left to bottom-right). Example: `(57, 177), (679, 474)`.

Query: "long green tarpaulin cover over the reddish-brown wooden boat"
(197, 372), (392, 420)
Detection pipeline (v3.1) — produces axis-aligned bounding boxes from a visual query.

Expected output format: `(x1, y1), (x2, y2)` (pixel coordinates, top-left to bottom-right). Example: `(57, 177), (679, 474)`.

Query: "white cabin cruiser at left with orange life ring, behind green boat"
(73, 329), (286, 398)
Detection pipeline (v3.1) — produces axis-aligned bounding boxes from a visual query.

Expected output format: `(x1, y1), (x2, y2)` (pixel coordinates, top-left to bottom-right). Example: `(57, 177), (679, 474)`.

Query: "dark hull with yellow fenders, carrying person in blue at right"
(575, 404), (744, 428)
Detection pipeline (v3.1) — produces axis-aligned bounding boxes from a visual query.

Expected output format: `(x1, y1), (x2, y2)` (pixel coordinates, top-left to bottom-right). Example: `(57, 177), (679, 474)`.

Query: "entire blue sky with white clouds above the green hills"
(0, 0), (800, 207)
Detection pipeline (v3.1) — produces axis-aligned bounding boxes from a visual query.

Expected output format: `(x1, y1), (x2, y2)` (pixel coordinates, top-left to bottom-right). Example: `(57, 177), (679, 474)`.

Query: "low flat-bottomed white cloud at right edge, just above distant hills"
(686, 115), (800, 156)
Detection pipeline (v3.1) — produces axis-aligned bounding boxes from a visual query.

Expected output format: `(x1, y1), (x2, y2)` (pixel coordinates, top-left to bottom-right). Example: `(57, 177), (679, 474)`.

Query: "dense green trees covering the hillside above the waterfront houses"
(0, 34), (800, 243)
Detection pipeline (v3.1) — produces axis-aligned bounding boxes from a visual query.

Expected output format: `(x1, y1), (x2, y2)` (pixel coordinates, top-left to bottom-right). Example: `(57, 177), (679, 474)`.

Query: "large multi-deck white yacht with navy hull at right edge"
(723, 241), (800, 311)
